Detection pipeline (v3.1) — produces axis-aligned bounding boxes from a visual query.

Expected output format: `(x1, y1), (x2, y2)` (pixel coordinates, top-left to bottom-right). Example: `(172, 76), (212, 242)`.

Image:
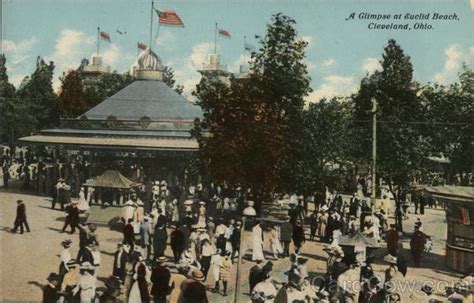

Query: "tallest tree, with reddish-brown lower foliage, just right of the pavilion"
(194, 14), (310, 210)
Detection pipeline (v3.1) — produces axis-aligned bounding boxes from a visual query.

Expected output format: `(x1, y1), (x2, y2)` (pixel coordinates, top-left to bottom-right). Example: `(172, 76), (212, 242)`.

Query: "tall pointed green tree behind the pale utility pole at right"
(354, 40), (427, 230)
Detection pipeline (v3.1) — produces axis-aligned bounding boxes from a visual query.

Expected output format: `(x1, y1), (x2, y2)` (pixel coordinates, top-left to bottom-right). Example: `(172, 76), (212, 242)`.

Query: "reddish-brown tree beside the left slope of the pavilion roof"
(58, 70), (87, 118)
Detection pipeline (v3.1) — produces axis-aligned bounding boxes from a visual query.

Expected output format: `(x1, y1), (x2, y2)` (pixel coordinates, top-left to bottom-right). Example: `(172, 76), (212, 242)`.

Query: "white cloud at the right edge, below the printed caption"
(433, 44), (474, 84)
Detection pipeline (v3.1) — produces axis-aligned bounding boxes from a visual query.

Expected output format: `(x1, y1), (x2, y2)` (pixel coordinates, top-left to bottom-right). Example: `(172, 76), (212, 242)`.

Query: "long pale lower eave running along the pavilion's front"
(18, 135), (199, 151)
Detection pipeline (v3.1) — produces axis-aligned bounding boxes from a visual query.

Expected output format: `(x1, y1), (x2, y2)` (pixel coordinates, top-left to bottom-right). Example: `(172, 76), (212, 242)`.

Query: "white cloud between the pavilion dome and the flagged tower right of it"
(175, 42), (214, 100)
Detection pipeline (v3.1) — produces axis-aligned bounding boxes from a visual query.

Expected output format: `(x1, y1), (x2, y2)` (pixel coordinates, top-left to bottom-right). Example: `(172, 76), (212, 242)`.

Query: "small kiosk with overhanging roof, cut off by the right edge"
(425, 186), (474, 273)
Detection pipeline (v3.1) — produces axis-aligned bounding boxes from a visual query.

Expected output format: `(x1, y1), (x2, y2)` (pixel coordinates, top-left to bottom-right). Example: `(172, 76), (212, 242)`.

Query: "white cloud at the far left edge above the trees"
(0, 37), (37, 87)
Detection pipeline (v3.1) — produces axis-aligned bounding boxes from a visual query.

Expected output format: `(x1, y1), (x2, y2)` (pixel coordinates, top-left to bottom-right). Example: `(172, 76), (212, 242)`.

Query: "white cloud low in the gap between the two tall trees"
(306, 75), (357, 103)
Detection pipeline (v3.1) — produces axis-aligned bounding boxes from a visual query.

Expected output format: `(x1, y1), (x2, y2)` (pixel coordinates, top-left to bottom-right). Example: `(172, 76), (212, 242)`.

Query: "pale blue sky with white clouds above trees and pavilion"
(2, 0), (474, 102)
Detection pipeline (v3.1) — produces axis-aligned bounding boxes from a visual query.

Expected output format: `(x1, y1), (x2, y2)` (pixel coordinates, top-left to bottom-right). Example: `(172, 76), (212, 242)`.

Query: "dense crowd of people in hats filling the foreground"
(5, 148), (470, 303)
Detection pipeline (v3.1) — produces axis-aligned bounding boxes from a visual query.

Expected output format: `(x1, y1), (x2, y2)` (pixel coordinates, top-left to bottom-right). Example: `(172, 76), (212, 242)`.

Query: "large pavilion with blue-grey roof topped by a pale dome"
(19, 48), (202, 182)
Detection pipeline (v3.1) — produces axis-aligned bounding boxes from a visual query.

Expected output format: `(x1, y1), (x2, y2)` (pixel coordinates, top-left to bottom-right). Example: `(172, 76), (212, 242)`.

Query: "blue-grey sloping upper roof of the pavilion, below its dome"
(83, 80), (202, 120)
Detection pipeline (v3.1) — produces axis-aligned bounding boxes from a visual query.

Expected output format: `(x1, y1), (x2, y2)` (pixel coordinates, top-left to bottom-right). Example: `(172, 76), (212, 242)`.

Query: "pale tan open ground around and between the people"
(0, 186), (460, 302)
